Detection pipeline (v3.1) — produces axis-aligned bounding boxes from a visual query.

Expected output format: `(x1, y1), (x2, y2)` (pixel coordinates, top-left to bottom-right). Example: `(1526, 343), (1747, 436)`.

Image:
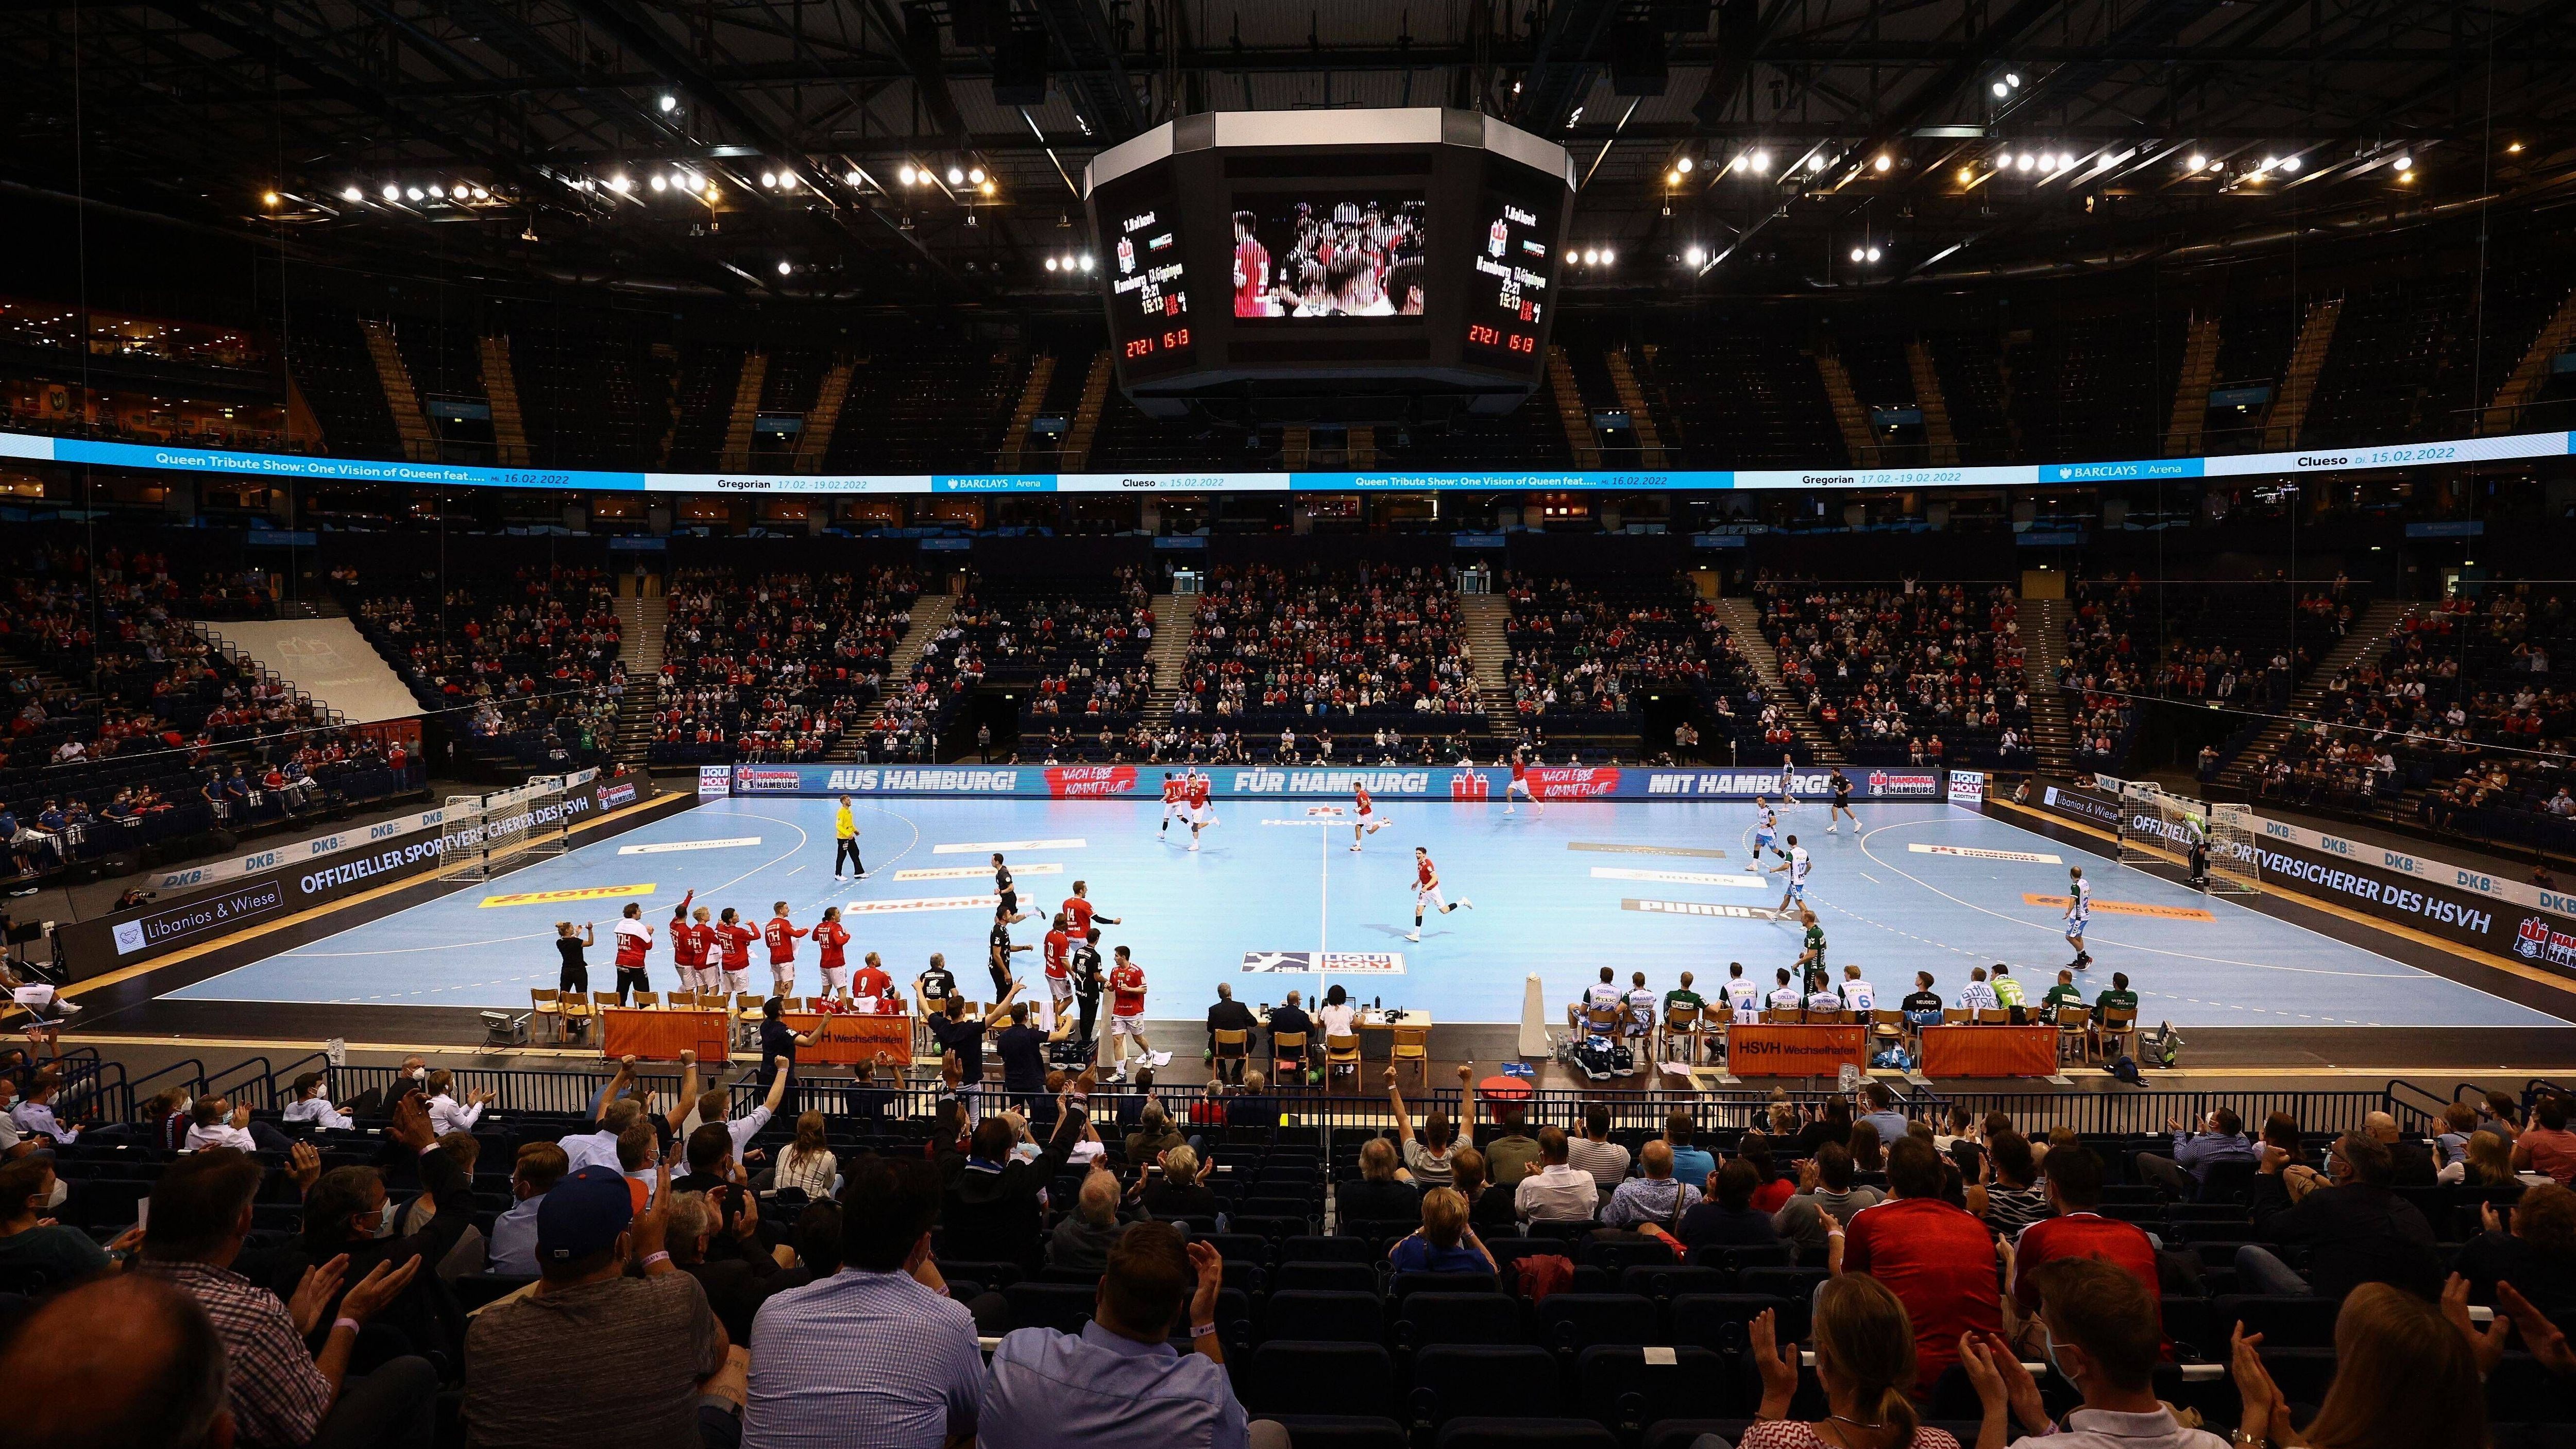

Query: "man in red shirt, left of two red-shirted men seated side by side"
(1839, 1137), (1999, 1395)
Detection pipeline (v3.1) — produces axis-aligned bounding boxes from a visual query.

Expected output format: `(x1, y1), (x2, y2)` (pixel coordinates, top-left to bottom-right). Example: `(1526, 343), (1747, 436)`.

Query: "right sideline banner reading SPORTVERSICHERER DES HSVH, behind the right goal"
(2040, 785), (2576, 976)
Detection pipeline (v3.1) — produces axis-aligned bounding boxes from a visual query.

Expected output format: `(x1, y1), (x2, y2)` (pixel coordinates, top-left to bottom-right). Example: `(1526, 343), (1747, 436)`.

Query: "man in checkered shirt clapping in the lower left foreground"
(137, 1148), (438, 1449)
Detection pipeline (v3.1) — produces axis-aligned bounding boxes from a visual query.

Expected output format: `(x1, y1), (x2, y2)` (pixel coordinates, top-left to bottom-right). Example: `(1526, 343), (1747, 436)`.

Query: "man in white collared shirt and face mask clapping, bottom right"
(1958, 1258), (2228, 1449)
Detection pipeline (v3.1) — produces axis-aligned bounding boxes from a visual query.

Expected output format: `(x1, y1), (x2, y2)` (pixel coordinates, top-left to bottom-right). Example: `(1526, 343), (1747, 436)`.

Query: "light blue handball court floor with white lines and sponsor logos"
(175, 798), (2561, 1027)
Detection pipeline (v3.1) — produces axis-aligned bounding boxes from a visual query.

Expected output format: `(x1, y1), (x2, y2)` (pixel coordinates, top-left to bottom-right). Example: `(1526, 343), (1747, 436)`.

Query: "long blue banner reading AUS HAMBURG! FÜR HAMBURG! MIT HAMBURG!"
(732, 764), (1947, 800)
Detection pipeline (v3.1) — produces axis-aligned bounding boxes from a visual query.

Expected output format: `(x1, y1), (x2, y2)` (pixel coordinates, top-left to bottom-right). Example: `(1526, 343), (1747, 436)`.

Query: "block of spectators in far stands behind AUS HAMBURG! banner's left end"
(649, 569), (920, 764)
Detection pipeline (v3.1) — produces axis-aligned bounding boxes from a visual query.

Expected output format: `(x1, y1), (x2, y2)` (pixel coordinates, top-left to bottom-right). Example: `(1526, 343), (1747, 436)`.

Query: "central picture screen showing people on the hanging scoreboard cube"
(1231, 191), (1430, 322)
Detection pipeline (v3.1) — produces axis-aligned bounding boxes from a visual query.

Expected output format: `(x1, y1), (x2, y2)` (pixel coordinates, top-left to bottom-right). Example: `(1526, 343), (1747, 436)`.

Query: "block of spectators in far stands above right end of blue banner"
(1754, 576), (2030, 767)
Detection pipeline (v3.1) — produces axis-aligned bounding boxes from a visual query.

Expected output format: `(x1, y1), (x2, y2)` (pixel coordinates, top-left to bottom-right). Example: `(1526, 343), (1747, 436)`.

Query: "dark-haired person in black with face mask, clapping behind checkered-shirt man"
(304, 1094), (474, 1361)
